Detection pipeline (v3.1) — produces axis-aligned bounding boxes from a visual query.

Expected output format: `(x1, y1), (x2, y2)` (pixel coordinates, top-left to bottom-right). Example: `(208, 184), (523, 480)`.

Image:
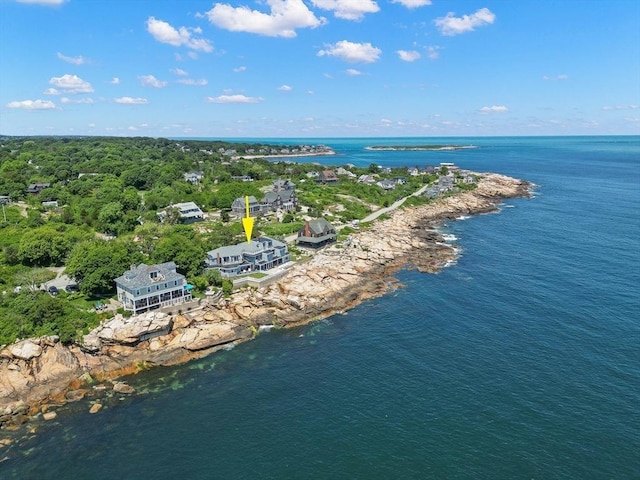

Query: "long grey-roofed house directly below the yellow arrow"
(205, 237), (291, 278)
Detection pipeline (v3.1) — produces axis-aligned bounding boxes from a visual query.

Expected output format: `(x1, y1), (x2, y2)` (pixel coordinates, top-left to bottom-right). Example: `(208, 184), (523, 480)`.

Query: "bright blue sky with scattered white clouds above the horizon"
(0, 0), (640, 138)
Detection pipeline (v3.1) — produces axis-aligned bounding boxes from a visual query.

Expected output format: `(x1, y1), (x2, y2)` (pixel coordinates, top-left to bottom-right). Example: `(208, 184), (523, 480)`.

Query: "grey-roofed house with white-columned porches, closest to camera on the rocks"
(114, 262), (191, 315)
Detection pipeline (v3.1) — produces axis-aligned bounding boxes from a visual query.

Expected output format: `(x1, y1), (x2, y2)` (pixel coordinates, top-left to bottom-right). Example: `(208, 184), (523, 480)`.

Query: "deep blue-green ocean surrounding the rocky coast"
(0, 136), (640, 480)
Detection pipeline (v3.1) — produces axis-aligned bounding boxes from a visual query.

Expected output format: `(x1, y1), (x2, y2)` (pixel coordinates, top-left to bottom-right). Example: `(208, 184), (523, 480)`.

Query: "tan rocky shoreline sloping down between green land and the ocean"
(0, 174), (533, 436)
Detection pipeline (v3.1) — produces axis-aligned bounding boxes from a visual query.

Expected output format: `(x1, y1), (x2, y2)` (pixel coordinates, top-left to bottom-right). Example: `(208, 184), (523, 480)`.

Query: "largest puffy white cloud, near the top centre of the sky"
(206, 0), (326, 38)
